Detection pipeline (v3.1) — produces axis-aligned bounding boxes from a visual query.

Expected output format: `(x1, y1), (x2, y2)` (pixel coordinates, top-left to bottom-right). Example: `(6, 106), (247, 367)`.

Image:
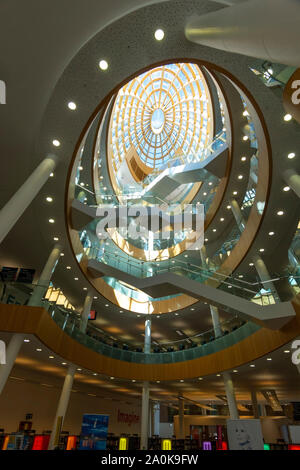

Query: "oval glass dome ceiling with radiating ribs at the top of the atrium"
(109, 63), (211, 179)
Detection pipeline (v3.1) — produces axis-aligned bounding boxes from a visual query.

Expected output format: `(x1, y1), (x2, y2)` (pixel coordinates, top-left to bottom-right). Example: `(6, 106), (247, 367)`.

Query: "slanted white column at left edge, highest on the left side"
(0, 155), (57, 243)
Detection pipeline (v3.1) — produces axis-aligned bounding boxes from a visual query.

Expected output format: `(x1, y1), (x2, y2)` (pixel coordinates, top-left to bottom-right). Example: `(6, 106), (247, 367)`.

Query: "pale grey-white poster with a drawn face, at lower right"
(227, 419), (264, 450)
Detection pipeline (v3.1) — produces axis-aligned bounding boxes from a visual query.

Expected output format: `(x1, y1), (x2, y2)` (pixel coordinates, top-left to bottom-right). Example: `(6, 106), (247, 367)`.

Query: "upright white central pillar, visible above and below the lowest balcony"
(140, 319), (151, 450)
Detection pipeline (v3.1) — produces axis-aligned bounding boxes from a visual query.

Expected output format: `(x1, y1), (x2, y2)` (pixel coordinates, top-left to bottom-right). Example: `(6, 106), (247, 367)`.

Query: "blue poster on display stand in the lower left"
(79, 414), (109, 450)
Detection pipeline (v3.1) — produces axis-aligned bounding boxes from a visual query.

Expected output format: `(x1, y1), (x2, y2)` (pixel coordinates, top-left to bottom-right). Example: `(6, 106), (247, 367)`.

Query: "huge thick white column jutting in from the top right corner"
(185, 0), (300, 67)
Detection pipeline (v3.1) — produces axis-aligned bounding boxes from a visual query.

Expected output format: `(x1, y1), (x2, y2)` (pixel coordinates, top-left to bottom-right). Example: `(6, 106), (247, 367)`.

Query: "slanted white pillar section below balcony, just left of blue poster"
(49, 365), (76, 450)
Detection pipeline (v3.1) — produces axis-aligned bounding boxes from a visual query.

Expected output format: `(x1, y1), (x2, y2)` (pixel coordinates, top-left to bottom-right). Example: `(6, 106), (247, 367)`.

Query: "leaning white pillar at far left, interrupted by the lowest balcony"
(0, 245), (61, 394)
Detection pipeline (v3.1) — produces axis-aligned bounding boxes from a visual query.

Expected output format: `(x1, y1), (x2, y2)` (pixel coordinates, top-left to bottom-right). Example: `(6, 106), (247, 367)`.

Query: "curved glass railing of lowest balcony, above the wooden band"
(0, 282), (260, 364)
